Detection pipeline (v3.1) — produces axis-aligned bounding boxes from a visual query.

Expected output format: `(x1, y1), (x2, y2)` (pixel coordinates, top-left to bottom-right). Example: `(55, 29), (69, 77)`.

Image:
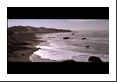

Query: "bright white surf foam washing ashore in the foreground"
(34, 46), (108, 62)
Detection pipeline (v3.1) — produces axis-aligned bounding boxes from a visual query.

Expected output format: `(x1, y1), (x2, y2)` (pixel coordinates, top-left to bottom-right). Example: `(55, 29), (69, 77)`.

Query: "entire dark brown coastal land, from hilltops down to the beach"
(7, 26), (71, 62)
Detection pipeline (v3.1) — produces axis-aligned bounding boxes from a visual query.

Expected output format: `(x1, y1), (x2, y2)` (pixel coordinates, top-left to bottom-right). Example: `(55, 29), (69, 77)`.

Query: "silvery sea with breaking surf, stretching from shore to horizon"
(31, 30), (109, 62)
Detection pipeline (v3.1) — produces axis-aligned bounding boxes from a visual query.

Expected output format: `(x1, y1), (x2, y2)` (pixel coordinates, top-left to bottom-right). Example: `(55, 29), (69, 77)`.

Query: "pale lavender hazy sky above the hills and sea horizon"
(8, 19), (109, 30)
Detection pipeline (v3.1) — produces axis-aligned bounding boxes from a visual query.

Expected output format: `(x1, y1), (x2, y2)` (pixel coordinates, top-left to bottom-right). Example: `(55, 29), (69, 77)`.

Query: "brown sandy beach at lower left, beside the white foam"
(8, 41), (41, 62)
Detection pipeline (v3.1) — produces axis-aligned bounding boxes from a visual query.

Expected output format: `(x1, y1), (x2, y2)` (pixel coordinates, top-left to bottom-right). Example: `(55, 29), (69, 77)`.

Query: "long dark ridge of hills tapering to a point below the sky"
(8, 26), (71, 33)
